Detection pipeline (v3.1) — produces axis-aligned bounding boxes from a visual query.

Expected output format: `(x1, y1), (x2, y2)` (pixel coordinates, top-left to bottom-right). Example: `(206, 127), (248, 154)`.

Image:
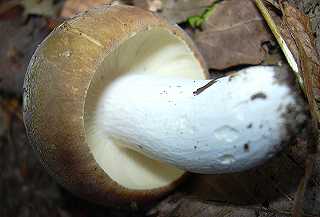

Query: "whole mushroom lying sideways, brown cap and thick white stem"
(23, 5), (307, 204)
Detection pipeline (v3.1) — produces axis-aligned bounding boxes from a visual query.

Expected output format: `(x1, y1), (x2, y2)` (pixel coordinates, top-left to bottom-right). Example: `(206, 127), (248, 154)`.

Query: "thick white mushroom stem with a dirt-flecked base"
(96, 67), (306, 173)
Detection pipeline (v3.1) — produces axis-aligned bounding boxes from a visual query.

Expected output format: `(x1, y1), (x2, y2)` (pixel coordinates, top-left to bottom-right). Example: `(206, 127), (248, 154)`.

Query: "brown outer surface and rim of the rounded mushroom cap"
(23, 5), (207, 205)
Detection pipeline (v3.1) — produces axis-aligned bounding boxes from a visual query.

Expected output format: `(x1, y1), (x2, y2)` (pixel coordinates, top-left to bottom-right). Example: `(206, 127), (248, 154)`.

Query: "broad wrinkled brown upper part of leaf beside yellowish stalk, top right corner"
(282, 4), (320, 134)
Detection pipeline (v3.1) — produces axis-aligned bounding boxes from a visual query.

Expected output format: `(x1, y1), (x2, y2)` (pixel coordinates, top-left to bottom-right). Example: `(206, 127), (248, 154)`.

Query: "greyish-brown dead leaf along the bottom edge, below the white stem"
(147, 193), (310, 217)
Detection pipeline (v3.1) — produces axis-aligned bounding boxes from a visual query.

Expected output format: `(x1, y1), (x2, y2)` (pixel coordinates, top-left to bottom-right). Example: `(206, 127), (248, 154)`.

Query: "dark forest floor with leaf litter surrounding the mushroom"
(0, 0), (320, 217)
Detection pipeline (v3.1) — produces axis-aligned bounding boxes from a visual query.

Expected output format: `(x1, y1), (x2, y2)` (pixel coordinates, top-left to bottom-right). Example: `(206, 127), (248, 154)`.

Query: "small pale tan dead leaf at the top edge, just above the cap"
(61, 0), (113, 17)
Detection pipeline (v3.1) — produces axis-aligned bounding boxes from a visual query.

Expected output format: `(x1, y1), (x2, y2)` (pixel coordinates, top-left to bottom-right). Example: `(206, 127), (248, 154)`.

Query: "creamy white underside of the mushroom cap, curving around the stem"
(85, 28), (204, 190)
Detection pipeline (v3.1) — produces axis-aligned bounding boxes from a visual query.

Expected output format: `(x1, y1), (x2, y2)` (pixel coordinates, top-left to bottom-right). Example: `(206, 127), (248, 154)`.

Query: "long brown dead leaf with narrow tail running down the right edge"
(281, 3), (320, 217)
